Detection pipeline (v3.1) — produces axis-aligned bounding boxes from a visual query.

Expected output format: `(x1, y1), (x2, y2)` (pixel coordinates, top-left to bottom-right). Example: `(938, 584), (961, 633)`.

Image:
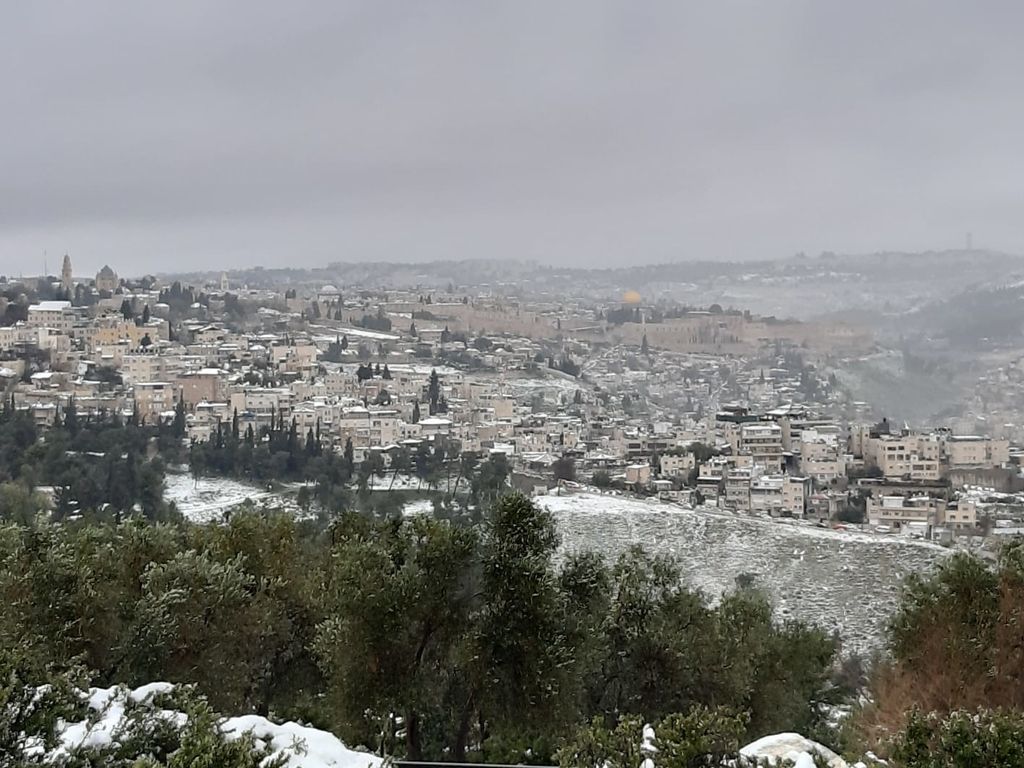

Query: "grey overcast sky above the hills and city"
(0, 0), (1024, 274)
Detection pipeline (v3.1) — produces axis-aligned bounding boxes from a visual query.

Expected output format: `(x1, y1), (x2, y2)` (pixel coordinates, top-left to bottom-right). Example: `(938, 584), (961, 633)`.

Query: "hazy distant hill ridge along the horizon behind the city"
(162, 250), (1024, 326)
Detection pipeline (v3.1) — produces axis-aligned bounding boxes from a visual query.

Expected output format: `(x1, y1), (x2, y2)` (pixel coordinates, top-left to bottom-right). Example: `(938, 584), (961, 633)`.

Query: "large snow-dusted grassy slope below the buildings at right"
(538, 494), (946, 651)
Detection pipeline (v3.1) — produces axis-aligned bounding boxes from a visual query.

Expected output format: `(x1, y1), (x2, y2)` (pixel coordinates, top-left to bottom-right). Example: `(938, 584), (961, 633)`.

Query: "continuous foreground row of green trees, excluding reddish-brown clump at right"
(0, 495), (837, 763)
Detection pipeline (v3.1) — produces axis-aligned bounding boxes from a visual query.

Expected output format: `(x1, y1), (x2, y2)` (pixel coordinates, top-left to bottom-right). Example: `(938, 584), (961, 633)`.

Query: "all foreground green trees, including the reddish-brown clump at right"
(0, 496), (1024, 768)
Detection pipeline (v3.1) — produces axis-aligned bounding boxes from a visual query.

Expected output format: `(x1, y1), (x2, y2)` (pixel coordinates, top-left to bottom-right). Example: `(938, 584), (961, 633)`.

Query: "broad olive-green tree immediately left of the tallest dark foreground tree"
(315, 516), (475, 760)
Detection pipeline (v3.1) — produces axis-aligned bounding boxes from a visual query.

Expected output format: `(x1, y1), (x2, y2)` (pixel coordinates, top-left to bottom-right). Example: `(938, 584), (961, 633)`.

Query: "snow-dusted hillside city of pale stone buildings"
(0, 257), (1024, 542)
